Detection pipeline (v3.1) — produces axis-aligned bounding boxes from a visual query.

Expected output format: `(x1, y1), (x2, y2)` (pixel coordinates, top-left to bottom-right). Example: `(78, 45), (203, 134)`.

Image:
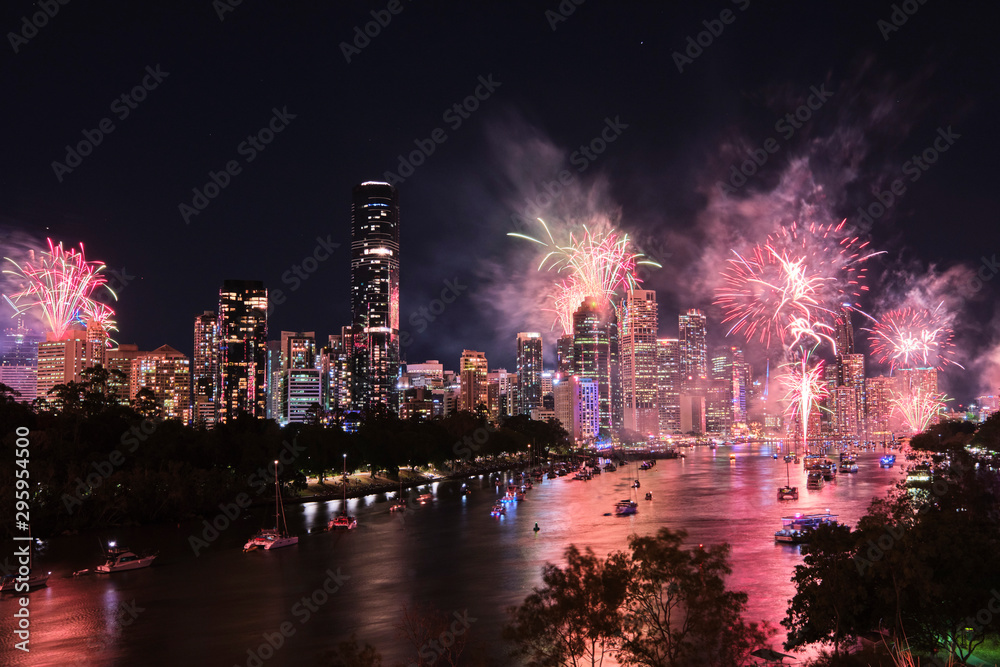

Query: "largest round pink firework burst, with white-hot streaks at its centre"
(715, 221), (881, 347)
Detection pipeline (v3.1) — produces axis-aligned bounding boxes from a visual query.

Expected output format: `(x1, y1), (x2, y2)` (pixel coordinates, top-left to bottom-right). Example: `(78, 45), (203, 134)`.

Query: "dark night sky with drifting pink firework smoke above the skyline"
(0, 0), (1000, 402)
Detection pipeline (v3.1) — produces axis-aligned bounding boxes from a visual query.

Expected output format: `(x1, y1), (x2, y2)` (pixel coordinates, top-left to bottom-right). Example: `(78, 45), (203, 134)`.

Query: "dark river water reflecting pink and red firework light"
(0, 444), (900, 667)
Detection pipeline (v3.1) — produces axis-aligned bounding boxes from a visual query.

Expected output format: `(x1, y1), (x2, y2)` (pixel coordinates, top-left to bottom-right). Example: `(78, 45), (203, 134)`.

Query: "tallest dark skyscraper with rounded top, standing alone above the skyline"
(351, 181), (399, 412)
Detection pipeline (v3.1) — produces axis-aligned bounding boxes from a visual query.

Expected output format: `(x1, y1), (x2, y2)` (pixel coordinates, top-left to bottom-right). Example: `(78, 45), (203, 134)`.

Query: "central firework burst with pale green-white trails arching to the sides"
(507, 218), (661, 333)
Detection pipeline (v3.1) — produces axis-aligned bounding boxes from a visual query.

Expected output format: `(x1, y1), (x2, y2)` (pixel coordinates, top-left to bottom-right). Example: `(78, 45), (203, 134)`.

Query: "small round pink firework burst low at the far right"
(866, 305), (961, 370)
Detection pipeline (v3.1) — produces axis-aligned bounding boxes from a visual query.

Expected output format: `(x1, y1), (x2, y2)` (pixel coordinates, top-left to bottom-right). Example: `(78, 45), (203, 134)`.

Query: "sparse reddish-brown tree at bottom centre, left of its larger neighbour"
(504, 545), (629, 667)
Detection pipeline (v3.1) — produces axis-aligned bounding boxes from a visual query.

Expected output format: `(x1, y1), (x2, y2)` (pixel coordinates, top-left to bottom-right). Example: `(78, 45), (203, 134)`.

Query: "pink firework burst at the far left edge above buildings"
(4, 239), (117, 338)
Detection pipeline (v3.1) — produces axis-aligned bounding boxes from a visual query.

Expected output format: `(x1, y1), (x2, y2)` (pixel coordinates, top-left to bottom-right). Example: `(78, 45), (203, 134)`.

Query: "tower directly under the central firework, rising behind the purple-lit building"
(573, 298), (617, 430)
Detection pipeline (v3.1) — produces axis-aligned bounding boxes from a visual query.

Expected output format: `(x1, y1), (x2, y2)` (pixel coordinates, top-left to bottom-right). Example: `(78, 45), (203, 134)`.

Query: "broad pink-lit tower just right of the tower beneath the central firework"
(619, 289), (660, 436)
